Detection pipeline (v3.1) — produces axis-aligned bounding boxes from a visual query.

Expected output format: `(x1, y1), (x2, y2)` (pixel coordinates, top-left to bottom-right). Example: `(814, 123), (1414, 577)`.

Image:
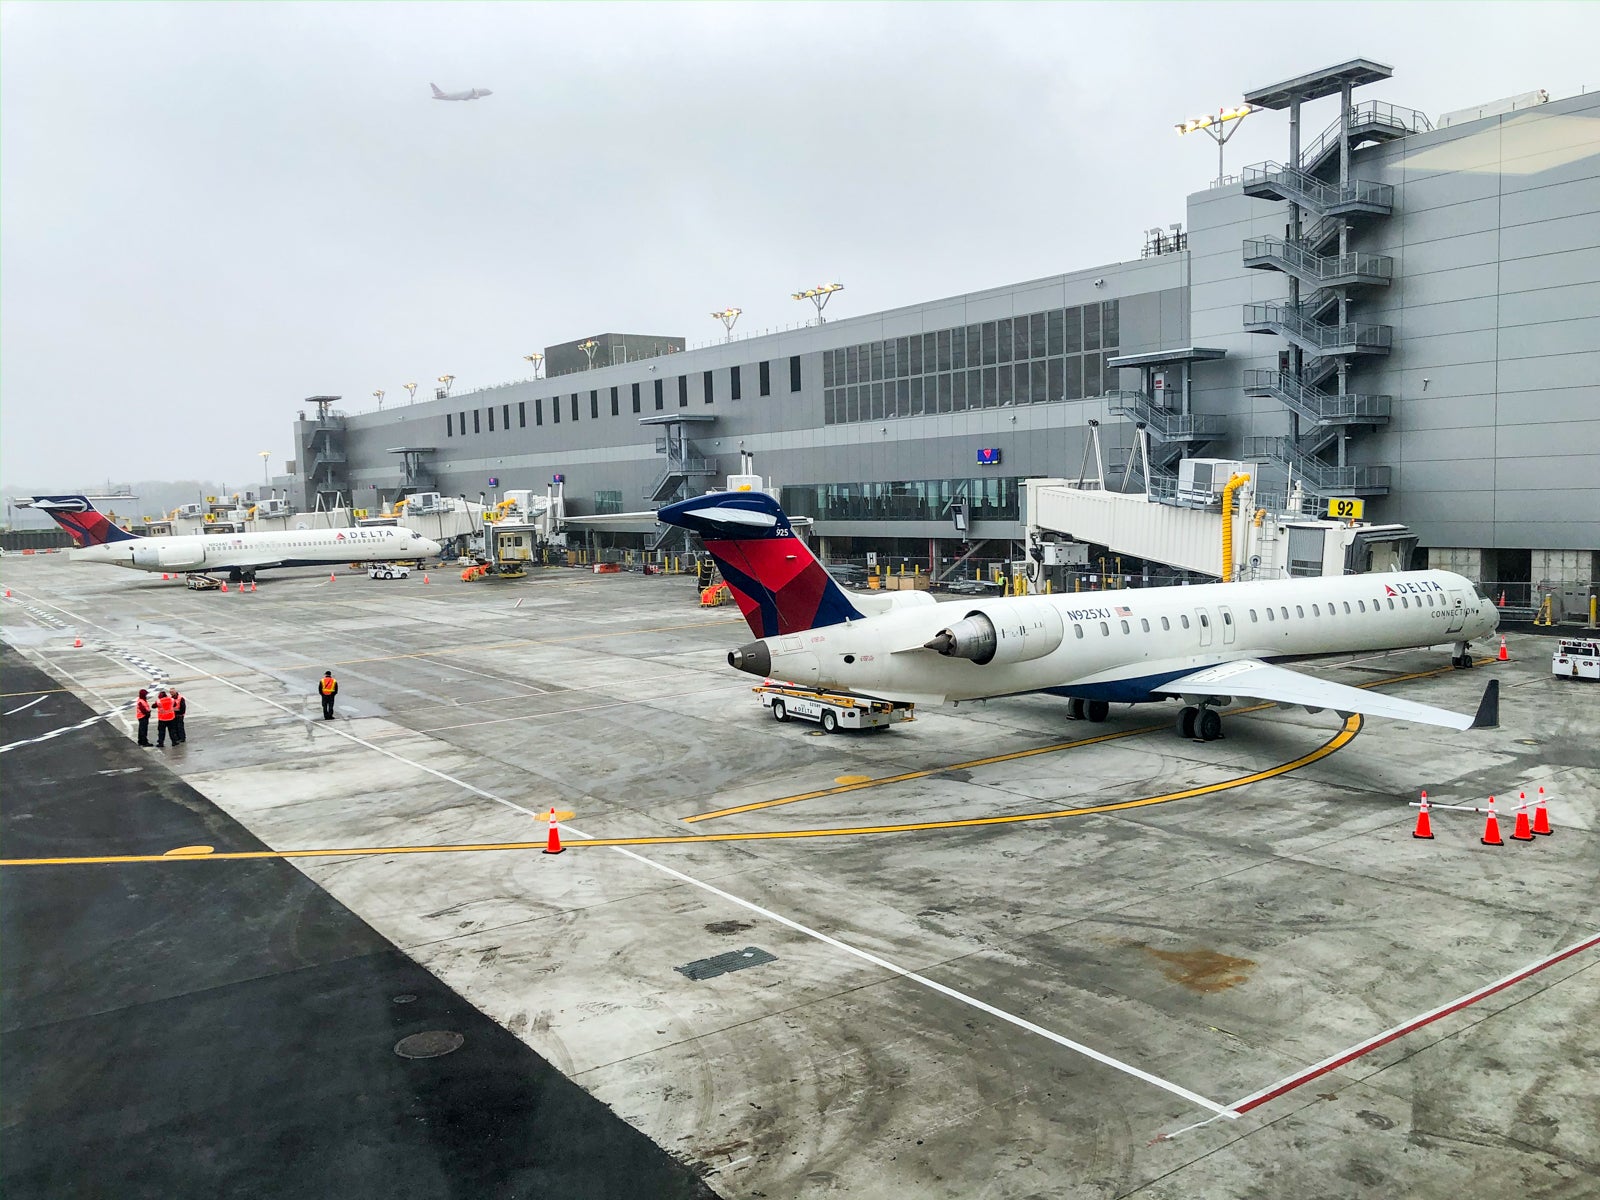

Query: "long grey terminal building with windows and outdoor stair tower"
(296, 59), (1600, 598)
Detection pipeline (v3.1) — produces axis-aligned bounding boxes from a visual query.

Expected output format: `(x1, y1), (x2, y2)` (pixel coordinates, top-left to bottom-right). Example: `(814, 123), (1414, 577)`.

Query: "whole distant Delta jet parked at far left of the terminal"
(18, 496), (438, 582)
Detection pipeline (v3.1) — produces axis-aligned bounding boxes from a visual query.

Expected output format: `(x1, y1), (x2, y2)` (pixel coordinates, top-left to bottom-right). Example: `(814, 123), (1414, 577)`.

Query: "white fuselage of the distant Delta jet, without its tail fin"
(67, 525), (438, 571)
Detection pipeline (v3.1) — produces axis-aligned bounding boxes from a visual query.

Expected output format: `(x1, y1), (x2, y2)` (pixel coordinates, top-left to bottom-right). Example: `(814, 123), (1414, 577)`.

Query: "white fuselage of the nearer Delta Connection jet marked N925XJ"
(738, 571), (1499, 702)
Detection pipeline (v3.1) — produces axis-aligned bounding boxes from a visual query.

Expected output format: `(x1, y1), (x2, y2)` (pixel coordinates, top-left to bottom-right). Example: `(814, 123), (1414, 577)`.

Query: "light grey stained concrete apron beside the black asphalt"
(0, 555), (1600, 1200)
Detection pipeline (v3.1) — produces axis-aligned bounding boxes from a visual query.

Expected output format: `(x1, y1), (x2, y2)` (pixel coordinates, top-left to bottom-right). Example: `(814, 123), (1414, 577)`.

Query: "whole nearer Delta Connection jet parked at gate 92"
(658, 491), (1499, 741)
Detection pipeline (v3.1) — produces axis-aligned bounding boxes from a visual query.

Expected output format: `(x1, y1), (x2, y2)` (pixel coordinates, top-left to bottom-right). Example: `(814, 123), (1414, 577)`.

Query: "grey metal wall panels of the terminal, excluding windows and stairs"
(315, 86), (1600, 566)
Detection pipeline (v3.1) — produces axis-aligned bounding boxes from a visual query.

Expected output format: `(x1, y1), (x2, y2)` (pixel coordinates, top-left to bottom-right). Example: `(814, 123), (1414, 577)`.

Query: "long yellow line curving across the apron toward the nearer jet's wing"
(0, 714), (1362, 867)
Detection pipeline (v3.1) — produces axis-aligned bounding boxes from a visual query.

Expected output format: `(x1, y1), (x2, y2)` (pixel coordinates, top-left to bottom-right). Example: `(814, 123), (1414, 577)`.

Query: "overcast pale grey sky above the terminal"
(0, 2), (1600, 488)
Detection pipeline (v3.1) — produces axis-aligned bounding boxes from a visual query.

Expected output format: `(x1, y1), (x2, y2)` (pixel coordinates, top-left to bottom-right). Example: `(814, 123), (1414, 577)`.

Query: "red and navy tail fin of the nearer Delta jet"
(656, 491), (862, 637)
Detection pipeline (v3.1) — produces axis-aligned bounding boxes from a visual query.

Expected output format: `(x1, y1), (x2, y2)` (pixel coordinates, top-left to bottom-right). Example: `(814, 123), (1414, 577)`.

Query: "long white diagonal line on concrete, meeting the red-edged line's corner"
(12, 588), (1238, 1120)
